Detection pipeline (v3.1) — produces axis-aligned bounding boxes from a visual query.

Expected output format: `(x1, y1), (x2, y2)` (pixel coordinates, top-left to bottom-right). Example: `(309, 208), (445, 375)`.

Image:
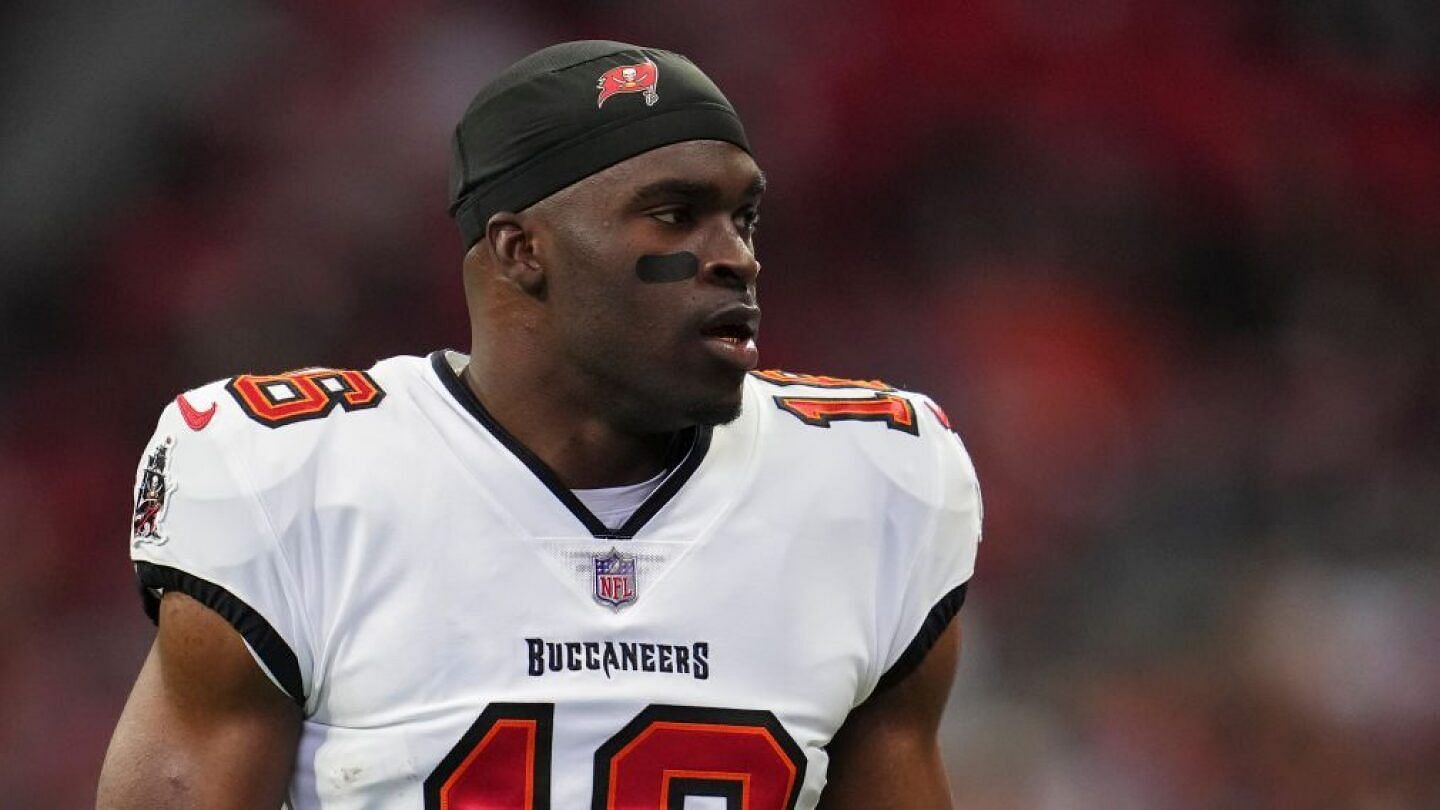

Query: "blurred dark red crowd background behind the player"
(0, 0), (1440, 810)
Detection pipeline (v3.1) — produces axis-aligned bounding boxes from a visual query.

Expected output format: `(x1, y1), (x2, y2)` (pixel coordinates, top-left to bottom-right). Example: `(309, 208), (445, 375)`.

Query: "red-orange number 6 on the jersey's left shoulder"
(225, 368), (384, 428)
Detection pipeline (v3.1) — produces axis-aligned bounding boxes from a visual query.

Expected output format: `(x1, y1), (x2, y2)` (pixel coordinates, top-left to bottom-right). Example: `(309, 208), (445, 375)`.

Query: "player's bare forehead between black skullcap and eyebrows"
(570, 141), (765, 199)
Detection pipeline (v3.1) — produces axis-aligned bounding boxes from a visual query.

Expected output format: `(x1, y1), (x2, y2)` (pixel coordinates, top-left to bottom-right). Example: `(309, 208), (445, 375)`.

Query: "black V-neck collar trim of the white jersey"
(431, 349), (713, 540)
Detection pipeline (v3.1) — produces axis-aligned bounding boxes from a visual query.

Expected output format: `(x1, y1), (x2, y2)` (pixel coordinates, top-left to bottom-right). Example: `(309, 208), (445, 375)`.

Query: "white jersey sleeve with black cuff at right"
(874, 403), (982, 692)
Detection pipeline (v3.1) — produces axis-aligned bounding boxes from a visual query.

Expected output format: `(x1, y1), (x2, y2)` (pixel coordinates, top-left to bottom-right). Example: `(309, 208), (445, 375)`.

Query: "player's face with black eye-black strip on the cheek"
(536, 141), (765, 431)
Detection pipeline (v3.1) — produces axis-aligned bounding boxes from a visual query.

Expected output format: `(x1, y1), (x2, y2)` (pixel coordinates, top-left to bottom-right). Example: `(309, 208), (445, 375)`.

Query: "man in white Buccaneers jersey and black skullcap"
(98, 42), (981, 810)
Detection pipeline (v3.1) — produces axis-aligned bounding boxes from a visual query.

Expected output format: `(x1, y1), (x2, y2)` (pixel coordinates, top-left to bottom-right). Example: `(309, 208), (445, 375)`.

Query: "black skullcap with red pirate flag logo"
(449, 40), (750, 248)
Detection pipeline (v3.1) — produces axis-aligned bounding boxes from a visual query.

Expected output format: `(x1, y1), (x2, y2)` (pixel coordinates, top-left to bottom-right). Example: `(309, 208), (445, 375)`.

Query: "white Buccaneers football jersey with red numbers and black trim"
(131, 352), (981, 810)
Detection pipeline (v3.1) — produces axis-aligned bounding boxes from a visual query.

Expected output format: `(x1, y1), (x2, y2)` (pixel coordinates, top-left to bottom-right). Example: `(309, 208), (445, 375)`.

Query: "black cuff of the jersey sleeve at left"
(135, 561), (305, 708)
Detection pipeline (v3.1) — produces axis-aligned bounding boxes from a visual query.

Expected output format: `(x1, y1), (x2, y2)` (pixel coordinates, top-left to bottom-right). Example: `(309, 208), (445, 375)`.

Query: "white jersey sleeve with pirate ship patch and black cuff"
(130, 404), (312, 706)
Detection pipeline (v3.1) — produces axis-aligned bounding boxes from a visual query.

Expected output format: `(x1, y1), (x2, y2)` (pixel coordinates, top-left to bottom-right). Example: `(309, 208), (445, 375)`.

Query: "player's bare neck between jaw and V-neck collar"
(461, 348), (674, 489)
